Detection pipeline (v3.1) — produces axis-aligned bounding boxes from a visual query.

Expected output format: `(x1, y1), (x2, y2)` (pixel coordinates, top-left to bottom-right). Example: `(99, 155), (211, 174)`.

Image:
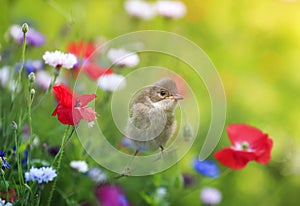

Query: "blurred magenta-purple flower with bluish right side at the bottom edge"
(95, 184), (130, 206)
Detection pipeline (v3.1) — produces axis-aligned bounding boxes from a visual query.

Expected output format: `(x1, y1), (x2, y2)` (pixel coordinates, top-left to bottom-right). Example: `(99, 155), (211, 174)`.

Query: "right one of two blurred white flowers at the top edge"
(156, 0), (186, 19)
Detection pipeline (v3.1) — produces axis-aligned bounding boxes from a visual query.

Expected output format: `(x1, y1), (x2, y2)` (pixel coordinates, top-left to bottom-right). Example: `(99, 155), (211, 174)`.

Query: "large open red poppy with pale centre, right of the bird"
(214, 124), (273, 169)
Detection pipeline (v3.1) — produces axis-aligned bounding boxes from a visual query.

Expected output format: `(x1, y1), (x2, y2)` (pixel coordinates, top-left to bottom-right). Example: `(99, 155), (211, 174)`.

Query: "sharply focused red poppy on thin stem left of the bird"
(52, 84), (97, 125)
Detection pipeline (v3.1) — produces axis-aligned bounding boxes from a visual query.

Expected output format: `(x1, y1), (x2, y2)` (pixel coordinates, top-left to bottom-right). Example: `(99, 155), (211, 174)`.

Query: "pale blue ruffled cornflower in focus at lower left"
(25, 167), (57, 184)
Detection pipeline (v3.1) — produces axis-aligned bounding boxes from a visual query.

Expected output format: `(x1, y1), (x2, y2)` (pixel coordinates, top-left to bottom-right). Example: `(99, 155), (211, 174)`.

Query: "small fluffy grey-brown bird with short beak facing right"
(125, 78), (183, 155)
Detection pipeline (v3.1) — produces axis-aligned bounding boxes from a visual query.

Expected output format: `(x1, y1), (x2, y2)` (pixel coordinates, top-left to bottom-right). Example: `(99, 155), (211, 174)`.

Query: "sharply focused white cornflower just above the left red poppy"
(43, 51), (77, 69)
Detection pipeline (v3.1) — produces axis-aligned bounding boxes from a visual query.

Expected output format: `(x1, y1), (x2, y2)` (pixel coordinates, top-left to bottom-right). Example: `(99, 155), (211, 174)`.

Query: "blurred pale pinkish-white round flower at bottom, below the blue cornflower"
(200, 187), (222, 205)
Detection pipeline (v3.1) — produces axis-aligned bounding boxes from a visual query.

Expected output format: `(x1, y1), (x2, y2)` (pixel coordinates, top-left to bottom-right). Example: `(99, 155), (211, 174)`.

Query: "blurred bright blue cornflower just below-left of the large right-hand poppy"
(193, 159), (220, 178)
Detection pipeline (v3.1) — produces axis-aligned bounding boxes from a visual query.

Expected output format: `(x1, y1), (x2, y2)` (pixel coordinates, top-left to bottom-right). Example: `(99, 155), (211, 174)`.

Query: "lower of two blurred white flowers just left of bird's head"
(97, 74), (126, 91)
